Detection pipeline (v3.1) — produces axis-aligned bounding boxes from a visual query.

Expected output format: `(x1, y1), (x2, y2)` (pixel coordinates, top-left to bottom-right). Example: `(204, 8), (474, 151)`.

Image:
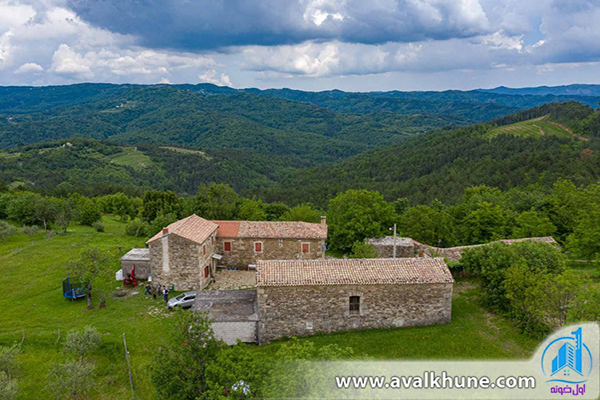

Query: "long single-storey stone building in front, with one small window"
(256, 258), (454, 343)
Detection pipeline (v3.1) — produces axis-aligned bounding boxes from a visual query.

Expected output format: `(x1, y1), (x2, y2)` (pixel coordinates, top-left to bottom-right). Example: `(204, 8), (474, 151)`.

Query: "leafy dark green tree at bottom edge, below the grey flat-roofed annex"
(150, 310), (223, 399)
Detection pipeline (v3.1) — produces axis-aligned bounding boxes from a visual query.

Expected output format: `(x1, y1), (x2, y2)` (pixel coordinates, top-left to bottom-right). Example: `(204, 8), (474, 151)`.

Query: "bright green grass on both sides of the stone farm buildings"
(0, 217), (537, 399)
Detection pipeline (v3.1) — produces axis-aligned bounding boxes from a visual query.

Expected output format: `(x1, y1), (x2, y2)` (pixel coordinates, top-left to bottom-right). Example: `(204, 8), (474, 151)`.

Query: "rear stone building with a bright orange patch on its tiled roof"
(212, 218), (327, 268)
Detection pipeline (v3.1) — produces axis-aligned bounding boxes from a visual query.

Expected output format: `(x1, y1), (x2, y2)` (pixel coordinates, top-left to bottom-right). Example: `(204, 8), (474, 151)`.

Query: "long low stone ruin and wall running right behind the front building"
(365, 236), (558, 261)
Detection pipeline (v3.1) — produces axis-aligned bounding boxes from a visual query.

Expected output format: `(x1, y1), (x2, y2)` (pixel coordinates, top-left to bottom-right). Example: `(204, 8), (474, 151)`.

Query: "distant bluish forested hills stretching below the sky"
(0, 84), (600, 158)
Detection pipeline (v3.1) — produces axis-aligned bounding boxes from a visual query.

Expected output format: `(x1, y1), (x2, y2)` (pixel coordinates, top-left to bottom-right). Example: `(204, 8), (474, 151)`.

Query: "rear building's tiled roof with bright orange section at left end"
(212, 221), (327, 239)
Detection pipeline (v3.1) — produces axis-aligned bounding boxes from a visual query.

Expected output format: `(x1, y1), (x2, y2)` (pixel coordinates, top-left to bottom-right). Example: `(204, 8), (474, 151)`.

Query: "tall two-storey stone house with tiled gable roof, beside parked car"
(146, 214), (218, 290)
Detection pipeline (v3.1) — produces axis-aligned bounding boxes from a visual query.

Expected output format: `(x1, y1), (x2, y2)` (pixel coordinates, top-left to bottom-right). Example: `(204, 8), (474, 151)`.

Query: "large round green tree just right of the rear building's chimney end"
(327, 190), (397, 250)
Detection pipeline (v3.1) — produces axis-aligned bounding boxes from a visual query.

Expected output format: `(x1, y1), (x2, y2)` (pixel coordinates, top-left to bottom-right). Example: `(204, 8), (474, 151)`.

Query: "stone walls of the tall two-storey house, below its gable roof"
(149, 231), (216, 290)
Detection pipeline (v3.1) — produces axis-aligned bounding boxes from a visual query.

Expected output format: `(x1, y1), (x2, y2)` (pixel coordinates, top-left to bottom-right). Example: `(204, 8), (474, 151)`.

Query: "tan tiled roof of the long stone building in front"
(256, 258), (454, 287)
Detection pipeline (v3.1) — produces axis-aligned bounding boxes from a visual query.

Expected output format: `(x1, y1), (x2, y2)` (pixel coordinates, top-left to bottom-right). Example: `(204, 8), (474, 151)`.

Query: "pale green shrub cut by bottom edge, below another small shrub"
(46, 360), (95, 400)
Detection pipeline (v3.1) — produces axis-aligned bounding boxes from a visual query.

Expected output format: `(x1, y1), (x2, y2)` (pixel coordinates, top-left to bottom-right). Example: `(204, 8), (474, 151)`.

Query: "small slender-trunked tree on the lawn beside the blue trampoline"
(69, 247), (110, 308)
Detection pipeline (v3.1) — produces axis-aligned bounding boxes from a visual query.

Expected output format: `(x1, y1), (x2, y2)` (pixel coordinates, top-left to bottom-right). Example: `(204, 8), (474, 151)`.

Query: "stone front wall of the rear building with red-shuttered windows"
(217, 237), (325, 268)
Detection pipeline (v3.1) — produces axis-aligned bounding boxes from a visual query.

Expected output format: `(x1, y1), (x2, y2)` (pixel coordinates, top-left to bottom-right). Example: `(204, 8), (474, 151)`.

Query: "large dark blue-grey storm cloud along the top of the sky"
(68, 0), (489, 51)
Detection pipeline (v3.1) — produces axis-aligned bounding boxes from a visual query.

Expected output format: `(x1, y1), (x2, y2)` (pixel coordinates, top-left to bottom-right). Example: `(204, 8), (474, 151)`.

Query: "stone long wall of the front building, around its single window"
(257, 284), (452, 343)
